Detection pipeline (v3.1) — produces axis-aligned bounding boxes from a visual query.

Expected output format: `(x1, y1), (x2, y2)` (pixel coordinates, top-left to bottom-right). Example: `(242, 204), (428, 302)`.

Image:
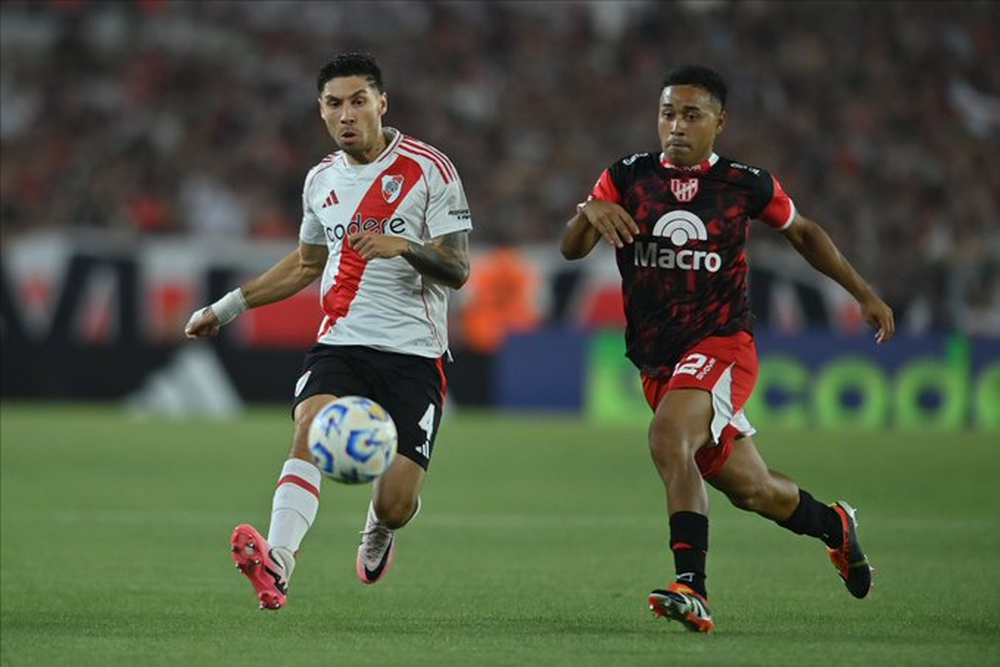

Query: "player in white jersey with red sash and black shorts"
(185, 53), (472, 609)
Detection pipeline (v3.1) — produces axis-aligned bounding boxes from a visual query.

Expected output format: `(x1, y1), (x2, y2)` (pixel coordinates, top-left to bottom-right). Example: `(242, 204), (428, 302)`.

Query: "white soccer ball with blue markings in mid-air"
(309, 396), (398, 484)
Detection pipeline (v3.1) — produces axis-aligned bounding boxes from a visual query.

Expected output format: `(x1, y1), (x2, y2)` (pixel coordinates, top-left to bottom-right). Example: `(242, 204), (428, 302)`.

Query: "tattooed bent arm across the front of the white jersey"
(348, 230), (469, 289)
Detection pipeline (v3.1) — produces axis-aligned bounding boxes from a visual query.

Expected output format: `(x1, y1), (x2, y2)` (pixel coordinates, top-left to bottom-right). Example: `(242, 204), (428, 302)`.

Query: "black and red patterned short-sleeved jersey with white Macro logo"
(588, 153), (795, 377)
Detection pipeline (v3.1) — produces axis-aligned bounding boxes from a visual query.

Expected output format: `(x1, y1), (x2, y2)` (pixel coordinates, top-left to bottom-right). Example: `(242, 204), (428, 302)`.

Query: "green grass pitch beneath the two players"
(0, 404), (1000, 666)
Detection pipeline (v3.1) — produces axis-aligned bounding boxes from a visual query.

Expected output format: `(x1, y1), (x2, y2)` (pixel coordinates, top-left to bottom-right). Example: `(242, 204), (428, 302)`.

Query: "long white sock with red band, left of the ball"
(267, 459), (322, 553)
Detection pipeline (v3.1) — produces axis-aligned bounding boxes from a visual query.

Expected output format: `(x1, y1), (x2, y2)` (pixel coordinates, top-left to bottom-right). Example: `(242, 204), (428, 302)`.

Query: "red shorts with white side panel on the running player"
(642, 331), (758, 479)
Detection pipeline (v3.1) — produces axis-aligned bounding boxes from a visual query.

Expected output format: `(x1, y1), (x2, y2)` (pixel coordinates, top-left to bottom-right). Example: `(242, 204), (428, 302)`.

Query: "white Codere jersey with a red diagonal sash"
(299, 128), (472, 358)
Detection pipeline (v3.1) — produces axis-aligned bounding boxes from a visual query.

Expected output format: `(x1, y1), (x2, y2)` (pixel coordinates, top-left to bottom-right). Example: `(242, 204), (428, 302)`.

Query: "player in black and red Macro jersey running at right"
(560, 65), (895, 632)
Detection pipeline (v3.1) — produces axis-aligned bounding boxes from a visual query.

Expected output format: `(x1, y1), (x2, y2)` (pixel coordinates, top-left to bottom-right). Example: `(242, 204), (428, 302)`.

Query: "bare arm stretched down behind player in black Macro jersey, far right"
(784, 215), (896, 343)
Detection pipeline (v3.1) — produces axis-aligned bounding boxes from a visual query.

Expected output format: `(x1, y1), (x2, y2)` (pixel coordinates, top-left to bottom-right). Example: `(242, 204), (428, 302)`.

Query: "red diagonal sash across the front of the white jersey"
(318, 155), (423, 338)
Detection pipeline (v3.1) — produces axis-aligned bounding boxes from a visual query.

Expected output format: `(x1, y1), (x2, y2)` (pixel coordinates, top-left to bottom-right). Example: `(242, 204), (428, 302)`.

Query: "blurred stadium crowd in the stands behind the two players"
(0, 0), (1000, 335)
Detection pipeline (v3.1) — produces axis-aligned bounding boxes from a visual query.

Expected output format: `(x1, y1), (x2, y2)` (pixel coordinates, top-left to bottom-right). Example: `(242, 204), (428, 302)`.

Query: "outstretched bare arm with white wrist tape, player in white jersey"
(184, 243), (328, 338)
